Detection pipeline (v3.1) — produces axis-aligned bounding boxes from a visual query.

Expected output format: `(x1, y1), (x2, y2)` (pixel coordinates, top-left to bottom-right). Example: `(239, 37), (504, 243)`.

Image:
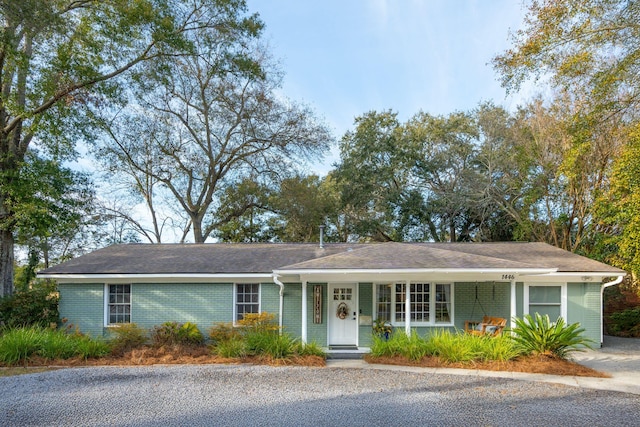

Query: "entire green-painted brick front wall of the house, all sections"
(58, 282), (601, 347)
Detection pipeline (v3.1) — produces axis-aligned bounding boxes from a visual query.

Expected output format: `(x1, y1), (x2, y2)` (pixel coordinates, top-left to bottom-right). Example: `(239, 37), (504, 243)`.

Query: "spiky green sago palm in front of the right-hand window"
(512, 313), (593, 359)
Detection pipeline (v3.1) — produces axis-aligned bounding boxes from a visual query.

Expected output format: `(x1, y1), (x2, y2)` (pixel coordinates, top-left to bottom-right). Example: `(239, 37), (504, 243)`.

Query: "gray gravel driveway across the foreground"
(0, 365), (640, 427)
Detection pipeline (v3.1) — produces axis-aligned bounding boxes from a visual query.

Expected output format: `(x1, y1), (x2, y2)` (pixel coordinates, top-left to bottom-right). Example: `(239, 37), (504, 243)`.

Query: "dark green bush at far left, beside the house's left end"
(0, 285), (59, 328)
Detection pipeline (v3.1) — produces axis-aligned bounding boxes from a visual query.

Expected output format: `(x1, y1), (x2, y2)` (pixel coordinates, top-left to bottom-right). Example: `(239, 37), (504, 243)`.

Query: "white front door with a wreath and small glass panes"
(328, 283), (358, 345)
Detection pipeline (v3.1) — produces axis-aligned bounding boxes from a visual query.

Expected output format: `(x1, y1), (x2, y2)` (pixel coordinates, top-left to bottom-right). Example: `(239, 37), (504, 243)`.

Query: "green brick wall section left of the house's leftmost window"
(58, 283), (104, 336)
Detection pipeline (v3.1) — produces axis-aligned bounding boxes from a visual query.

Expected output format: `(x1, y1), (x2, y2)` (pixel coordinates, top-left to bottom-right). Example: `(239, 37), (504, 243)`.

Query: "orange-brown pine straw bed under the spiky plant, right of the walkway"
(365, 355), (611, 378)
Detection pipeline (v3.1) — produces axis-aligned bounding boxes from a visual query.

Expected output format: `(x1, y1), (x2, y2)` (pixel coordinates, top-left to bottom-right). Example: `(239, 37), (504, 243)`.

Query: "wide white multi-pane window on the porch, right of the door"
(375, 283), (453, 324)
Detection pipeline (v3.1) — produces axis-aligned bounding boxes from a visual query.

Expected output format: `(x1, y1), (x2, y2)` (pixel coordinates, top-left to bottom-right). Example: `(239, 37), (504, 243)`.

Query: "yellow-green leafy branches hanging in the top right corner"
(493, 0), (640, 117)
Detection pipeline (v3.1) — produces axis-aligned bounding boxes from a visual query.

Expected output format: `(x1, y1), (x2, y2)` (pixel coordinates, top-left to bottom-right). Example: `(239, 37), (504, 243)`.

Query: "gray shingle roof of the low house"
(40, 242), (623, 275)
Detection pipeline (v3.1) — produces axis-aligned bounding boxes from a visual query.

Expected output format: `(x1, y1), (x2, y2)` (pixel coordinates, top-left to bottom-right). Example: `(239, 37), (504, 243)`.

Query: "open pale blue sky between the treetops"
(247, 0), (525, 174)
